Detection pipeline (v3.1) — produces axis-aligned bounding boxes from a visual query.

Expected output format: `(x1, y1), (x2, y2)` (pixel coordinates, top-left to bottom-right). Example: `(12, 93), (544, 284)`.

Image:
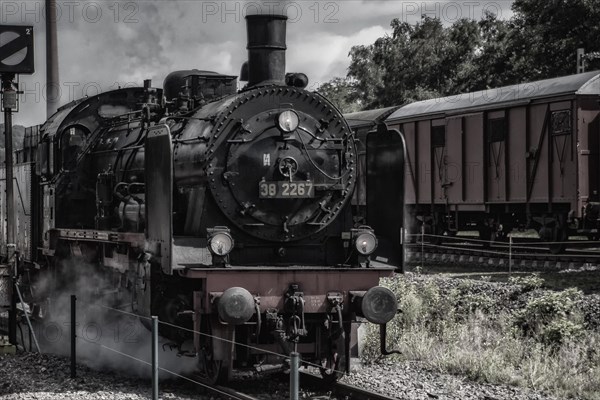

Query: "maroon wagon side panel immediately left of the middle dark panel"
(463, 114), (485, 205)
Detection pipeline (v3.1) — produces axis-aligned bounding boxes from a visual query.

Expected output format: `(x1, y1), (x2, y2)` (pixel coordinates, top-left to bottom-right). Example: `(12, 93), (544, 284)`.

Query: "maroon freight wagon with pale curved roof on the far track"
(386, 72), (600, 251)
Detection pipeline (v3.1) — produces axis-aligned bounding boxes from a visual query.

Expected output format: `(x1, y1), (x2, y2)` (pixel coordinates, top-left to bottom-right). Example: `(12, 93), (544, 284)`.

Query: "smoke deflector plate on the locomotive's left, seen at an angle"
(144, 125), (173, 275)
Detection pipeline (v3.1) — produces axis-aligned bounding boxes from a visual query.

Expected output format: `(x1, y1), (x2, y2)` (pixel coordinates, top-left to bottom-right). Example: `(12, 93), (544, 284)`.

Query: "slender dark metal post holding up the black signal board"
(2, 74), (17, 345)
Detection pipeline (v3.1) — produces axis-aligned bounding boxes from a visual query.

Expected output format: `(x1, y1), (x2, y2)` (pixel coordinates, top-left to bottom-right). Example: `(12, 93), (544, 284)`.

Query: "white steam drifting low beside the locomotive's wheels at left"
(22, 263), (196, 378)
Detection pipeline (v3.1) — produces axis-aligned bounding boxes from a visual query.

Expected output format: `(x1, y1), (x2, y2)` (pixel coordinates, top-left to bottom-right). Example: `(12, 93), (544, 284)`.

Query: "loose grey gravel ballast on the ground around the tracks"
(0, 274), (600, 400)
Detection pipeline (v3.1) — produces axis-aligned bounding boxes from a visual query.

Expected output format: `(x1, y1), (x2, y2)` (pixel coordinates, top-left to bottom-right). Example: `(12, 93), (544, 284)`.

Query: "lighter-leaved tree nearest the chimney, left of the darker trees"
(348, 18), (479, 108)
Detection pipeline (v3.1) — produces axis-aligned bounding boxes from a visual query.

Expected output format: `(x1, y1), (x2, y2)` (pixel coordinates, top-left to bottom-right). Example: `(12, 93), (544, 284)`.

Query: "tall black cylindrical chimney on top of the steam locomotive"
(246, 15), (287, 86)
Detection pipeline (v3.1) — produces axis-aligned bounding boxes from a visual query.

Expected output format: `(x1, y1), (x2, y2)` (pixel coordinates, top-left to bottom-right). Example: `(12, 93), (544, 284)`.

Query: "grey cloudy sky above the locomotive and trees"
(0, 0), (512, 125)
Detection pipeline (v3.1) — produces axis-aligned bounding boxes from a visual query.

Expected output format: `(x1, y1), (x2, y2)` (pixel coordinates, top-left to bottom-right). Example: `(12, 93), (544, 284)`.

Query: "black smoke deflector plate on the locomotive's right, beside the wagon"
(367, 123), (406, 272)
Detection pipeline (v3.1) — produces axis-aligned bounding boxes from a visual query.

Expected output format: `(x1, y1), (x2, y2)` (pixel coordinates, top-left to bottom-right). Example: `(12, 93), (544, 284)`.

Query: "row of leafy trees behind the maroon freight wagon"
(322, 0), (600, 109)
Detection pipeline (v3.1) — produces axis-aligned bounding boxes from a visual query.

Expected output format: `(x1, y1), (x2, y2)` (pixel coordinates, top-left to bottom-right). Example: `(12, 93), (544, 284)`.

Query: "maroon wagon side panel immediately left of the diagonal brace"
(506, 107), (528, 203)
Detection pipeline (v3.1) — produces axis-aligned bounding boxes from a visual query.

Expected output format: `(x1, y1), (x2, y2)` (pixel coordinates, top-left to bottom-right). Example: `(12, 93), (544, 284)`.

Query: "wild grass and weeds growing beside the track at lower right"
(363, 276), (600, 400)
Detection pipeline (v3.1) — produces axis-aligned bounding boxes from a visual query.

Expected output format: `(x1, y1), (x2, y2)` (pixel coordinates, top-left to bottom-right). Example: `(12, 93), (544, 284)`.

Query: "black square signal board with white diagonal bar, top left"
(0, 25), (34, 74)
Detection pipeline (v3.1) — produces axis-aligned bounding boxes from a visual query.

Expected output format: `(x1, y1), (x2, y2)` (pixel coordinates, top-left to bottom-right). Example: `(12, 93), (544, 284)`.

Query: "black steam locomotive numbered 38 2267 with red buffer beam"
(2, 15), (404, 380)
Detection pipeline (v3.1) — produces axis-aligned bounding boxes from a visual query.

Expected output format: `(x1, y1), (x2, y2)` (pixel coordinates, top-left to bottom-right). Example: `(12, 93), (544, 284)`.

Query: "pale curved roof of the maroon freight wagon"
(387, 71), (600, 122)
